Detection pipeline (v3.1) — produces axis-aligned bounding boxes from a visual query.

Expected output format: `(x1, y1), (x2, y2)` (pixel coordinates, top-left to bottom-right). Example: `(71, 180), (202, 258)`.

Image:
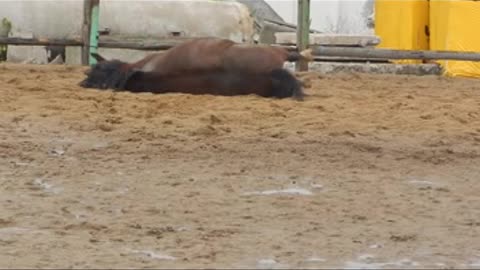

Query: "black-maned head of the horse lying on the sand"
(79, 54), (134, 89)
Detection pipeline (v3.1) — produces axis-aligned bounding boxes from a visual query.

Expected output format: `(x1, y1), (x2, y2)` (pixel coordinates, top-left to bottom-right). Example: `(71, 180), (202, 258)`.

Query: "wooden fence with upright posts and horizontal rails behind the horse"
(0, 0), (480, 71)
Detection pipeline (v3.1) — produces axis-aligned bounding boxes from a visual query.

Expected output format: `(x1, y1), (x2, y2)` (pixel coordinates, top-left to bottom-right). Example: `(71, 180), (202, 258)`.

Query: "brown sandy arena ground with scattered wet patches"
(0, 62), (480, 268)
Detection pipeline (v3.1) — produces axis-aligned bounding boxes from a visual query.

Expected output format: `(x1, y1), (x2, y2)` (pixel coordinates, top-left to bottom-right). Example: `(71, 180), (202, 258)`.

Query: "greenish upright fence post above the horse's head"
(82, 0), (100, 65)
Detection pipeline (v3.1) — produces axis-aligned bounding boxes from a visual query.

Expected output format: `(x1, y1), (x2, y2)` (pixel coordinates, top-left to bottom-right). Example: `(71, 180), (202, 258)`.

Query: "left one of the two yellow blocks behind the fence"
(375, 0), (429, 64)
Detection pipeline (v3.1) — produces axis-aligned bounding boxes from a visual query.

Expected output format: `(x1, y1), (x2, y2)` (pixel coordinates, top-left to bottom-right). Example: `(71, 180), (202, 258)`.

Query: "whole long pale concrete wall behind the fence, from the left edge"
(0, 0), (255, 63)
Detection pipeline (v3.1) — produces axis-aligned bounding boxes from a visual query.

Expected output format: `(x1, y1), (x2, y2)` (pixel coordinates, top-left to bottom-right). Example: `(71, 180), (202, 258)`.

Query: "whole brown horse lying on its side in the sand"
(80, 38), (312, 97)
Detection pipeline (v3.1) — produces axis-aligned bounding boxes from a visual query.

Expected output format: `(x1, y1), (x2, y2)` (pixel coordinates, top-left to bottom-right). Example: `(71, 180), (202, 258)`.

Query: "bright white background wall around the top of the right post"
(266, 0), (373, 34)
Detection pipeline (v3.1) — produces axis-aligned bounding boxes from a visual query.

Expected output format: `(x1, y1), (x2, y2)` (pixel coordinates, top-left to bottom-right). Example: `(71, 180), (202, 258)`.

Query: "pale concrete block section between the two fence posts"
(100, 0), (254, 42)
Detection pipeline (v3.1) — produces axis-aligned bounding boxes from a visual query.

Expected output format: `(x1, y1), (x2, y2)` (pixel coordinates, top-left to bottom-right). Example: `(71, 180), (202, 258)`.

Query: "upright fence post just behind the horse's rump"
(296, 0), (310, 71)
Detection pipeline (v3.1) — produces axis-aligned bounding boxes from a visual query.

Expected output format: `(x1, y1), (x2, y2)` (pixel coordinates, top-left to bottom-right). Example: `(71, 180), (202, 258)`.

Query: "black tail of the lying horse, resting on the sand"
(270, 68), (305, 101)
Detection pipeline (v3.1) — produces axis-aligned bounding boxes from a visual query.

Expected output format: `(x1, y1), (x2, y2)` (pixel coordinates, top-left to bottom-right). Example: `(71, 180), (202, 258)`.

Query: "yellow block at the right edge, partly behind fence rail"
(430, 0), (480, 78)
